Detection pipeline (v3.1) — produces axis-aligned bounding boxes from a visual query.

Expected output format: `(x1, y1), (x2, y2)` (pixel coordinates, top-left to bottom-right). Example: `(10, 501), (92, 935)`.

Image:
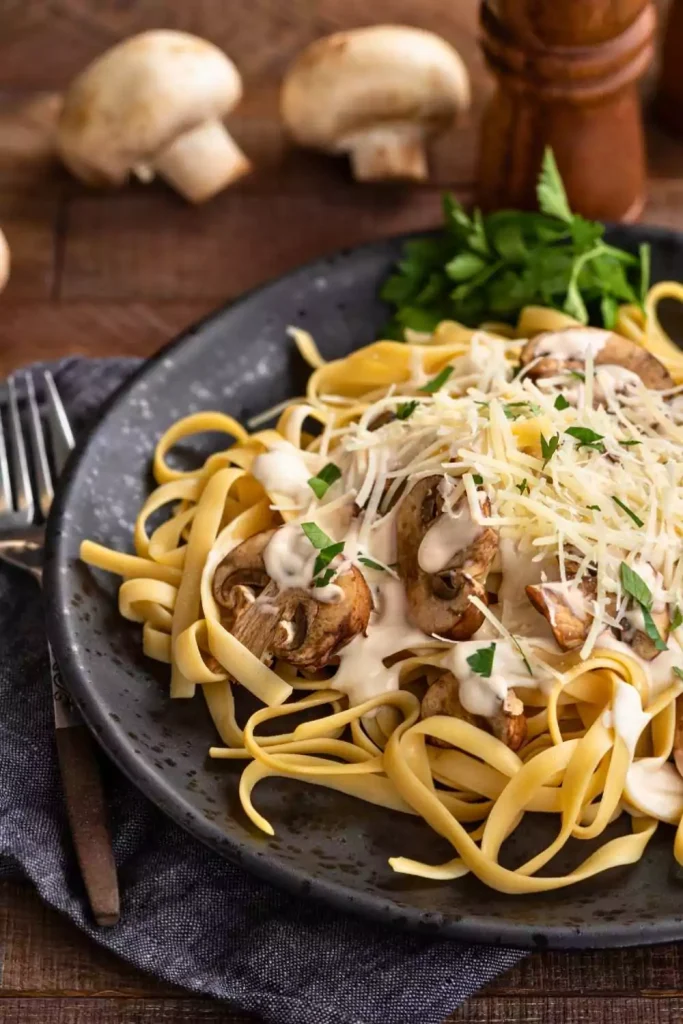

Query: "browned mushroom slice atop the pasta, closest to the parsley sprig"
(520, 327), (674, 391)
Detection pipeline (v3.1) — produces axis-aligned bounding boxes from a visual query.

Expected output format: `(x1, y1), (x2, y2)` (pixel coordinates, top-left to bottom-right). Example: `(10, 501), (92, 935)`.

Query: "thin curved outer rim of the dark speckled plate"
(44, 224), (683, 950)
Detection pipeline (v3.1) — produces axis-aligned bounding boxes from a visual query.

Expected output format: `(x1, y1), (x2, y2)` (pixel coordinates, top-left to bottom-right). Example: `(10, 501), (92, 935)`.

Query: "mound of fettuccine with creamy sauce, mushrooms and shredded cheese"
(81, 283), (683, 893)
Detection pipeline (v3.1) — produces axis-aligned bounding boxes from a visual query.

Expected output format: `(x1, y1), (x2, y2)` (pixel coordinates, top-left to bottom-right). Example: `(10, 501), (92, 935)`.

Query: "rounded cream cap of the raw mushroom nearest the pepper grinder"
(281, 25), (470, 152)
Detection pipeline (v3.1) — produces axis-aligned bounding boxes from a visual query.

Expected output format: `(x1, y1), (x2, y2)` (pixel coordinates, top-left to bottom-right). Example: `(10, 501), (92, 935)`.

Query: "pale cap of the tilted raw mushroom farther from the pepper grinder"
(57, 30), (242, 185)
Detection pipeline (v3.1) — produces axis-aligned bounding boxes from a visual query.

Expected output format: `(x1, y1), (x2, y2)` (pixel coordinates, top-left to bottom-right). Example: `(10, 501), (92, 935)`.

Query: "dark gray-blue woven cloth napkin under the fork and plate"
(0, 359), (524, 1024)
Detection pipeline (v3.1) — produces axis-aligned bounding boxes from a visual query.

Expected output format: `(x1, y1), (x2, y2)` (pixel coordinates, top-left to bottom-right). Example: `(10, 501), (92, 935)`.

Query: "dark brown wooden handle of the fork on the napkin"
(50, 650), (120, 926)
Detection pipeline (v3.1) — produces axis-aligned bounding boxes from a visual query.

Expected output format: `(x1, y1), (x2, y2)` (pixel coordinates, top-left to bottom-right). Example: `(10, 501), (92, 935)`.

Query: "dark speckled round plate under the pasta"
(45, 228), (683, 947)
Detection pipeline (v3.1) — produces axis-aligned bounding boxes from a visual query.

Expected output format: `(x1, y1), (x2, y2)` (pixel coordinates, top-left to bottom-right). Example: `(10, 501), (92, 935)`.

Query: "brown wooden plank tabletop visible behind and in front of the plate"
(0, 0), (683, 1024)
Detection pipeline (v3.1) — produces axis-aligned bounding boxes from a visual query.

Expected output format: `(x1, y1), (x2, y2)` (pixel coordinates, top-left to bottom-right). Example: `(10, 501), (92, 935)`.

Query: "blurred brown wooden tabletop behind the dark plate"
(0, 0), (683, 374)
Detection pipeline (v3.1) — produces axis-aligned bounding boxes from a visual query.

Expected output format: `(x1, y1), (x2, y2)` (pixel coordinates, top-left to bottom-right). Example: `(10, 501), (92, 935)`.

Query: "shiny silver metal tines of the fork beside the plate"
(0, 370), (74, 530)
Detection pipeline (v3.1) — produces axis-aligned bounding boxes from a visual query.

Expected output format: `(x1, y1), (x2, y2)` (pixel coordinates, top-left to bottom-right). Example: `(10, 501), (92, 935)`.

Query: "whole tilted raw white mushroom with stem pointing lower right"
(57, 30), (251, 203)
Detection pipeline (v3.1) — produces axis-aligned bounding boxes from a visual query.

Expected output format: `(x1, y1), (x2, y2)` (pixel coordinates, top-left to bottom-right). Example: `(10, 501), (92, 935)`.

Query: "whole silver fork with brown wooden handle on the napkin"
(0, 371), (119, 925)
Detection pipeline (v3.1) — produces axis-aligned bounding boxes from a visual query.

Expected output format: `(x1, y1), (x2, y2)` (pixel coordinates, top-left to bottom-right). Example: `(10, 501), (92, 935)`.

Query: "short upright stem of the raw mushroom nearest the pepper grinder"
(342, 125), (428, 181)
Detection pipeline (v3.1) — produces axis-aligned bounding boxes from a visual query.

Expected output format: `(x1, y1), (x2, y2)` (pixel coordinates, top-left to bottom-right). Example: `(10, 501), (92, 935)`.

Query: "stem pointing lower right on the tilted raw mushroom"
(154, 121), (251, 203)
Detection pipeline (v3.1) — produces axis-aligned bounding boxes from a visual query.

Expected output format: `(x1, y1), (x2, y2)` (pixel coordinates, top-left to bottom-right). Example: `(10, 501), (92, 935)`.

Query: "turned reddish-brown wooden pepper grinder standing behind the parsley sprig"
(478, 0), (655, 220)
